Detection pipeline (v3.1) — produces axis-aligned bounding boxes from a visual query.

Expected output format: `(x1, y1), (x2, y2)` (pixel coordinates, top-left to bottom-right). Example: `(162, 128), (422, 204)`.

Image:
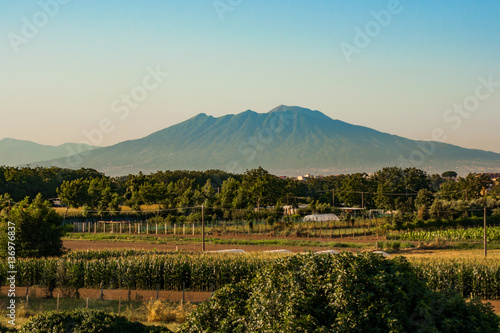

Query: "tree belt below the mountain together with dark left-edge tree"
(0, 167), (500, 256)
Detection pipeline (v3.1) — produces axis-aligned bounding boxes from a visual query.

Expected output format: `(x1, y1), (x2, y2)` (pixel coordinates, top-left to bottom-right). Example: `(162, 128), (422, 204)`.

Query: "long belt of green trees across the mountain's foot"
(0, 163), (500, 214)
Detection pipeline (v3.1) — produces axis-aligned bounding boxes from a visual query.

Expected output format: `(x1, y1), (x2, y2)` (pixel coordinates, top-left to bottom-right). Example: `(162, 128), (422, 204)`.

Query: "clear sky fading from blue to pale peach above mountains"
(0, 0), (500, 153)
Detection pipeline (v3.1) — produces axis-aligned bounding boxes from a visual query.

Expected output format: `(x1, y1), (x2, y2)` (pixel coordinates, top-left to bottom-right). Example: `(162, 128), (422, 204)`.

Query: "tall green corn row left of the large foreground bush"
(0, 254), (274, 291)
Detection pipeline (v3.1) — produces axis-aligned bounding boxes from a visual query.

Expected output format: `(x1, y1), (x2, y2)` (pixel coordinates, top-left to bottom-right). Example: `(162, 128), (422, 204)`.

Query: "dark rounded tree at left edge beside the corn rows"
(0, 194), (64, 257)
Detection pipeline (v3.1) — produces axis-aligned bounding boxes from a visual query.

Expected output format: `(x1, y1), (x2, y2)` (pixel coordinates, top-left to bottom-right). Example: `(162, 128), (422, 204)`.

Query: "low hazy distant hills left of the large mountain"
(0, 138), (97, 166)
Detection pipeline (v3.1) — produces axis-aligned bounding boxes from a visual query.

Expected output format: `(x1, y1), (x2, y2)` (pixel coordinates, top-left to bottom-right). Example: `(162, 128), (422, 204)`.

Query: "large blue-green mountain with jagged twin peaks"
(31, 105), (500, 175)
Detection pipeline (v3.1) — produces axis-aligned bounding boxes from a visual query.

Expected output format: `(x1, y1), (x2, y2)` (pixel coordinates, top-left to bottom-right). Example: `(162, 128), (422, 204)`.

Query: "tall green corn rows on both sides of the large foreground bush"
(0, 252), (500, 299)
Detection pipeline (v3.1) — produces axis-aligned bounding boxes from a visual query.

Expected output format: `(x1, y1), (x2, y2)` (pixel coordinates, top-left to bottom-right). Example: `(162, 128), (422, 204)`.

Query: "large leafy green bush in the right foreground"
(181, 252), (500, 333)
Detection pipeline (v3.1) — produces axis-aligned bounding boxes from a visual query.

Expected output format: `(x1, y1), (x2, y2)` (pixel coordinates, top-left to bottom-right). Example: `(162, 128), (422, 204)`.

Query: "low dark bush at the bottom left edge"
(19, 309), (170, 333)
